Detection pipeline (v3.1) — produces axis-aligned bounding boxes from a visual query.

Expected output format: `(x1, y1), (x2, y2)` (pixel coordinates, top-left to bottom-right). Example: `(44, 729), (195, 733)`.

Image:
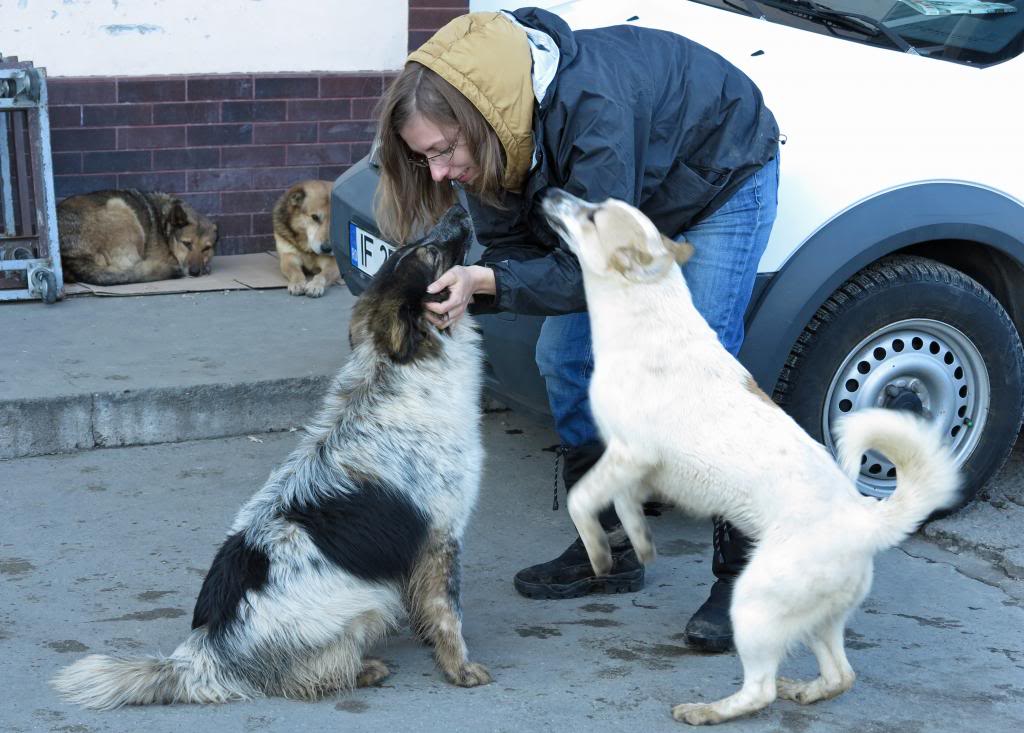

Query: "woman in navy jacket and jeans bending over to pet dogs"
(377, 8), (778, 650)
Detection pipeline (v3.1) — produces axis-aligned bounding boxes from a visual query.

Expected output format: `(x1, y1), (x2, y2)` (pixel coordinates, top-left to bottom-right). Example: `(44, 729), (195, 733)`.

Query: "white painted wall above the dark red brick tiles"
(0, 0), (409, 77)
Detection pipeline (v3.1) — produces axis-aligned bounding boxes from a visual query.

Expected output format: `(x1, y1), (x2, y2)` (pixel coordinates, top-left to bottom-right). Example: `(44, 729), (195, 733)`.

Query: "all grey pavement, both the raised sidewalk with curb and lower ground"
(0, 288), (1024, 733)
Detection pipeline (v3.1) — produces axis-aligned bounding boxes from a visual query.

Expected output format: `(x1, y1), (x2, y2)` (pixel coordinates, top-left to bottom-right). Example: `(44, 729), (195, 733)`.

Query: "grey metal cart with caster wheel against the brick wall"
(0, 55), (63, 303)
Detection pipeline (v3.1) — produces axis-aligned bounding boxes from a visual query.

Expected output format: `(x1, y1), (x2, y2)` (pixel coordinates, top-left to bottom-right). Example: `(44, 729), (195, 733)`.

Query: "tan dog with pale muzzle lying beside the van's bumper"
(273, 180), (341, 298)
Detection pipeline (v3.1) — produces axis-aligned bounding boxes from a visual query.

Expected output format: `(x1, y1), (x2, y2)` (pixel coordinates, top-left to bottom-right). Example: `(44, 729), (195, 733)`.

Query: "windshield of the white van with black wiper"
(693, 0), (1024, 67)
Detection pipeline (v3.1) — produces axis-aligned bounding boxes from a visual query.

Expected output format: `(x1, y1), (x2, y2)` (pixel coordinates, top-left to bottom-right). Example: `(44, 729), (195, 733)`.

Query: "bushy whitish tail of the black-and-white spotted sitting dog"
(51, 630), (252, 710)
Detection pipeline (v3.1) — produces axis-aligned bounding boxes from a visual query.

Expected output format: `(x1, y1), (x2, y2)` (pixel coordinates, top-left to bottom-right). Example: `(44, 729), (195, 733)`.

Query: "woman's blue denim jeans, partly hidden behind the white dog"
(537, 155), (778, 447)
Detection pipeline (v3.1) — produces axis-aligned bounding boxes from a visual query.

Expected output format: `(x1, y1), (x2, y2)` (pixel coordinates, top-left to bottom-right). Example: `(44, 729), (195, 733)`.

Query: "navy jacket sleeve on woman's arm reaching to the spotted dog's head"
(469, 97), (637, 315)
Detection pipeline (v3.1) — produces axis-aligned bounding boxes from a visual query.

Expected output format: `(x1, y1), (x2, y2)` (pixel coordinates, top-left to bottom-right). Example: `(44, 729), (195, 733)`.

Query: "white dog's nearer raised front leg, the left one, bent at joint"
(568, 443), (646, 575)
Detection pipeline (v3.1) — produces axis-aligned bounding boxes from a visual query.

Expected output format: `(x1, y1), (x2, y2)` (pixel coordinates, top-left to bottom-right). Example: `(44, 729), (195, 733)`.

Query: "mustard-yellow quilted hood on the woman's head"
(409, 12), (534, 191)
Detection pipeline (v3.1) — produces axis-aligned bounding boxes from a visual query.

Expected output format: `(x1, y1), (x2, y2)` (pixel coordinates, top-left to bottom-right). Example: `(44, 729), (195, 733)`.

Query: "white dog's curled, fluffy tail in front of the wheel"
(837, 408), (961, 550)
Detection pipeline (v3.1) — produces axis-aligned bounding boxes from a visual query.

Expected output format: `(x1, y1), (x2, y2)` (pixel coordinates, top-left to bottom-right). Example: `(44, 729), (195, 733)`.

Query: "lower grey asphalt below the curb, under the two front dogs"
(0, 413), (1024, 733)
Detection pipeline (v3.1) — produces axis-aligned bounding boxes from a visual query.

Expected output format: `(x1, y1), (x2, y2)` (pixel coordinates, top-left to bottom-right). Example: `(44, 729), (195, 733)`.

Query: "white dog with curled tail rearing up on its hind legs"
(544, 191), (959, 724)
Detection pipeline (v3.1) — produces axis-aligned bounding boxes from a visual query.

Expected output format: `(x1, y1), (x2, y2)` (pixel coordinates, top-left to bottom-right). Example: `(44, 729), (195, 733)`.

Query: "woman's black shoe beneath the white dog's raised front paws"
(514, 537), (643, 599)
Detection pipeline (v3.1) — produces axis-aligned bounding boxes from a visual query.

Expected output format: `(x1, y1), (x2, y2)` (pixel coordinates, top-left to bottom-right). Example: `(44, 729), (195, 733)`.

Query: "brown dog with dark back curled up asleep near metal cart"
(57, 188), (217, 285)
